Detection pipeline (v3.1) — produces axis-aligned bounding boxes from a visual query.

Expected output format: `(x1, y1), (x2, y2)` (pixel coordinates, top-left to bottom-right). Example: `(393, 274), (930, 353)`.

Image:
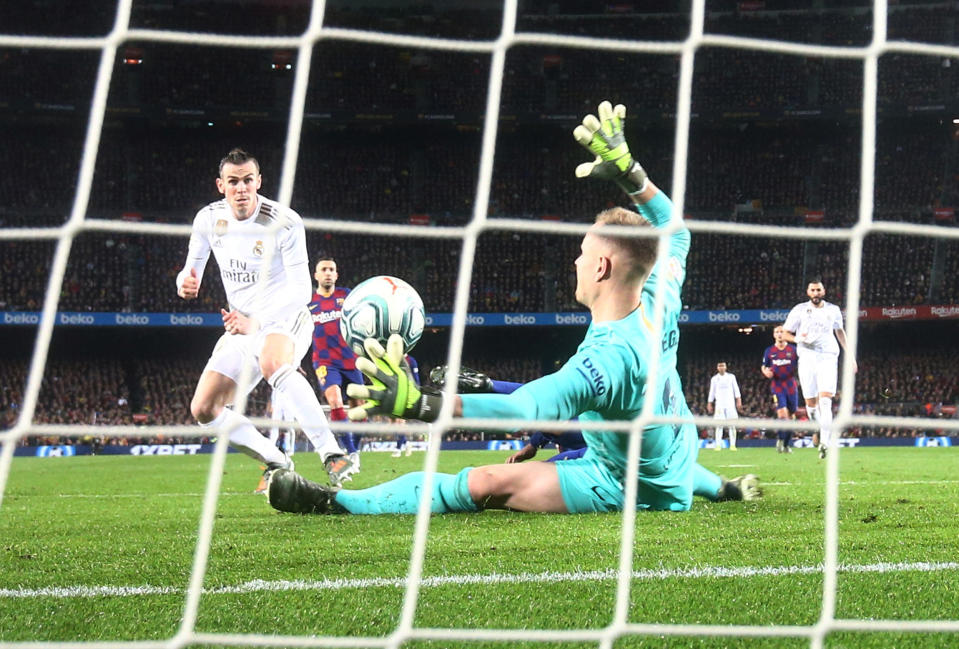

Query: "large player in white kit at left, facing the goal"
(176, 149), (352, 485)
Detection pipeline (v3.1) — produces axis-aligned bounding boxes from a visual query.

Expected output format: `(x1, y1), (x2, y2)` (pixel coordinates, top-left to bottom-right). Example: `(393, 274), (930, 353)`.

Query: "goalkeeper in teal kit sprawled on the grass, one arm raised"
(269, 102), (760, 514)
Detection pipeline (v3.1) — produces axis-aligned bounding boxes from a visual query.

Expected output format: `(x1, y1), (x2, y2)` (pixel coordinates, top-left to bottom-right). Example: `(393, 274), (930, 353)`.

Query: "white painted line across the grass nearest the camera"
(0, 561), (959, 599)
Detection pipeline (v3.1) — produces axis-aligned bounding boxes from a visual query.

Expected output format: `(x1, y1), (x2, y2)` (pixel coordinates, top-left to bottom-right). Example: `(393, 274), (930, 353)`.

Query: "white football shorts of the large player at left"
(203, 306), (313, 393)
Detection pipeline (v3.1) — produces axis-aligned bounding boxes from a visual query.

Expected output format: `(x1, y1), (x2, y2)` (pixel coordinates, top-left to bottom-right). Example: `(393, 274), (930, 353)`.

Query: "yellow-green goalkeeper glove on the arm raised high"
(573, 101), (647, 194)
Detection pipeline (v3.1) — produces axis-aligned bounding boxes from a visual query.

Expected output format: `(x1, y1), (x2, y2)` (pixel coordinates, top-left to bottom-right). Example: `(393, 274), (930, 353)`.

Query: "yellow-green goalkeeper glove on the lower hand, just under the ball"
(346, 334), (443, 422)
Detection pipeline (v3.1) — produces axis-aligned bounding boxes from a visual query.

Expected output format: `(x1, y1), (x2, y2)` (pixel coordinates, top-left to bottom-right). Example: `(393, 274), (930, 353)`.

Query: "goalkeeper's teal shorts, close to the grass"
(556, 432), (699, 514)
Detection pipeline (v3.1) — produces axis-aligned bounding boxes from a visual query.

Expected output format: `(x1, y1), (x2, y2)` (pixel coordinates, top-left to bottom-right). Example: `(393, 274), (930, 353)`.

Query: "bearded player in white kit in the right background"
(783, 279), (858, 458)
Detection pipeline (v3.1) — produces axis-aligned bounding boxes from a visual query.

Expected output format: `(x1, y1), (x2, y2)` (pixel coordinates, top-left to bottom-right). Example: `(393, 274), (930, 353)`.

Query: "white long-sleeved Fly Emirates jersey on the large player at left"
(177, 195), (313, 326)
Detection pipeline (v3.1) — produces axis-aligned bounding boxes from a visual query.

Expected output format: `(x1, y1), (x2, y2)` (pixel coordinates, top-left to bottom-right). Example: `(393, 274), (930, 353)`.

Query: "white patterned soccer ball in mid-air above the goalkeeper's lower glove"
(340, 275), (426, 356)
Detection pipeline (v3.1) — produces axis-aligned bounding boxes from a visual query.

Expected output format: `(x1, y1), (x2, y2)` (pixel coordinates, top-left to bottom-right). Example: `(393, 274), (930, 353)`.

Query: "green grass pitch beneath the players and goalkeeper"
(0, 447), (959, 649)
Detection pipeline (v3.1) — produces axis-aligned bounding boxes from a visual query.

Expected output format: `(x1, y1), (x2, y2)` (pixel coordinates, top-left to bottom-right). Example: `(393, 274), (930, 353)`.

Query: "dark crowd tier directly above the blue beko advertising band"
(0, 224), (959, 313)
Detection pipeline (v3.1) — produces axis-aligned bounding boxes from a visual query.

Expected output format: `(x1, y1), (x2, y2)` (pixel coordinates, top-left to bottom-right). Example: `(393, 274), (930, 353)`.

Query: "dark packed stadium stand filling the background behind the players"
(0, 0), (959, 434)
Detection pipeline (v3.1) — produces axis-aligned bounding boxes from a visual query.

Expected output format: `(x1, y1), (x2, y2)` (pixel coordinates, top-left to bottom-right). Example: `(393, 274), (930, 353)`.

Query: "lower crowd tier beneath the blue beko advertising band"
(0, 325), (959, 444)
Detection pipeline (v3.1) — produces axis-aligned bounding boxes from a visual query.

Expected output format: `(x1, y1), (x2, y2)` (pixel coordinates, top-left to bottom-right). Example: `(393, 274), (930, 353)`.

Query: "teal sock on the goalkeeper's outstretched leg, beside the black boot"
(334, 468), (479, 514)
